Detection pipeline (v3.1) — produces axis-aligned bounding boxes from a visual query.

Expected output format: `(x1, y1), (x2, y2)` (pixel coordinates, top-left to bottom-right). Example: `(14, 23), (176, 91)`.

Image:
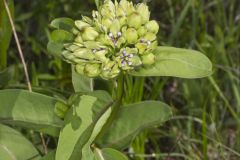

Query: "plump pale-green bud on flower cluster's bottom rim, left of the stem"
(84, 63), (101, 77)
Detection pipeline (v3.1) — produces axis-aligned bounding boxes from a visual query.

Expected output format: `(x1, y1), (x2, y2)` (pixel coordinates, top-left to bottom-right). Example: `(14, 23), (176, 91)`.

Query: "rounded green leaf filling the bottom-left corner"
(0, 124), (40, 160)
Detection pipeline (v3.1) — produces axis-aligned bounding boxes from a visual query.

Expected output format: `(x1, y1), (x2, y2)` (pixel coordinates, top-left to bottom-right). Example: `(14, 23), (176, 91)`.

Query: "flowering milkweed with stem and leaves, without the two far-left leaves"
(48, 0), (212, 160)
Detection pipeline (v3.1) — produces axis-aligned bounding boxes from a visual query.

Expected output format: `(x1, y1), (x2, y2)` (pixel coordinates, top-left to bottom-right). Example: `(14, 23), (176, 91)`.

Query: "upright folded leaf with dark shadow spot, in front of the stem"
(56, 91), (112, 160)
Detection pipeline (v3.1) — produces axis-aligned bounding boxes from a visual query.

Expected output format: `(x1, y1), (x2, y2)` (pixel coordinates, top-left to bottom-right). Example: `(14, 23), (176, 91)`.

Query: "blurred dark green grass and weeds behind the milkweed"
(0, 0), (240, 160)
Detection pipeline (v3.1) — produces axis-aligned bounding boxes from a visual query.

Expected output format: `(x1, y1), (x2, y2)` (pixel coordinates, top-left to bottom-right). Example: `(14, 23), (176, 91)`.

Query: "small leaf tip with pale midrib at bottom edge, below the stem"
(95, 148), (128, 160)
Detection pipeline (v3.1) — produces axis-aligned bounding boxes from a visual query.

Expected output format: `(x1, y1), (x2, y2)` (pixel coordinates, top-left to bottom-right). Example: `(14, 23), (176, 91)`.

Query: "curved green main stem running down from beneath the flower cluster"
(96, 74), (124, 139)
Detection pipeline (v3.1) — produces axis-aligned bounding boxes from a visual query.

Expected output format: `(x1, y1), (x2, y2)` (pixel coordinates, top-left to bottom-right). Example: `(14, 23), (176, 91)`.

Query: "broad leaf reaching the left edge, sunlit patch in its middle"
(0, 89), (63, 136)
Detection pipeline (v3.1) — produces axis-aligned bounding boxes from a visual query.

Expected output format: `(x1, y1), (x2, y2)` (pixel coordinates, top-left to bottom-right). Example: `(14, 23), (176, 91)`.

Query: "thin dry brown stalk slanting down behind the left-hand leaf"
(3, 0), (48, 154)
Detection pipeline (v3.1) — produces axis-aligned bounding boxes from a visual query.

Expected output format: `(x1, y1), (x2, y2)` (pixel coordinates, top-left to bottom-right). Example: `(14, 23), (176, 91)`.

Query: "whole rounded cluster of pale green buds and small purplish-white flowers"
(62, 0), (159, 79)
